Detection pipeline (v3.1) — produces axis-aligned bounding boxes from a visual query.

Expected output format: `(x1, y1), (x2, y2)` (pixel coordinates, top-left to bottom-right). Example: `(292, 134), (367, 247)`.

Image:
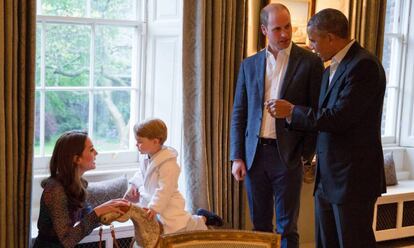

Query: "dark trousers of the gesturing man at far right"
(315, 184), (376, 248)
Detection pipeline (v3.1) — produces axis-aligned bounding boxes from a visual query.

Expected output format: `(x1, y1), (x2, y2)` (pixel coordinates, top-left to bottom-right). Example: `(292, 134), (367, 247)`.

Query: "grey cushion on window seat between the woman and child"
(86, 175), (128, 208)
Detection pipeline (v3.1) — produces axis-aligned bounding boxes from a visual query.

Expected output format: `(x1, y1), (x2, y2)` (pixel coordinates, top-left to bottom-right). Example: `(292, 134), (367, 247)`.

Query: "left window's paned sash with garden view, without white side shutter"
(34, 0), (146, 172)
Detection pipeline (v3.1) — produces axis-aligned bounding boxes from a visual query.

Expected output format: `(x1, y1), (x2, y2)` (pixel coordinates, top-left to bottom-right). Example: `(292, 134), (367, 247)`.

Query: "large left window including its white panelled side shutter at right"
(34, 0), (182, 172)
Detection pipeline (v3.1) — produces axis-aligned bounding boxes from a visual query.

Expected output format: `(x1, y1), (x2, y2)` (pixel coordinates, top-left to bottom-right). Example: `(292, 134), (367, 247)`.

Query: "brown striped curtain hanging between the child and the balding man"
(183, 0), (247, 228)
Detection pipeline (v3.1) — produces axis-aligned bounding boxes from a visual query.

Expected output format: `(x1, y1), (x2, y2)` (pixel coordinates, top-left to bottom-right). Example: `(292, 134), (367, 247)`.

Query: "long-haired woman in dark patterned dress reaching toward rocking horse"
(33, 131), (129, 248)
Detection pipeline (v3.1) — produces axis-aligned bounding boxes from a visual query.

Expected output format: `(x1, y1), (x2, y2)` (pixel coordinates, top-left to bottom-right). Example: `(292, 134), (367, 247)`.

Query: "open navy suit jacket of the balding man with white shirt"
(230, 44), (323, 169)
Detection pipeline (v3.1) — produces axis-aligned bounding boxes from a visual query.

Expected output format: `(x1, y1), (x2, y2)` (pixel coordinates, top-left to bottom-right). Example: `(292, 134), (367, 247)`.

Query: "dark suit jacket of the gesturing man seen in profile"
(289, 42), (386, 204)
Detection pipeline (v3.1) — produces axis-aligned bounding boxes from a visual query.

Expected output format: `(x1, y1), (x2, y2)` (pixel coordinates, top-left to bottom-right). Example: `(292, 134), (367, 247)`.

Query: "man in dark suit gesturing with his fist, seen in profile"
(268, 9), (386, 248)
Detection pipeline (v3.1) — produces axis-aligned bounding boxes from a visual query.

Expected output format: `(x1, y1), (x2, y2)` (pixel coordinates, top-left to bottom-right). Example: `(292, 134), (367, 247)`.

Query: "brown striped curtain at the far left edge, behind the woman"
(0, 0), (36, 248)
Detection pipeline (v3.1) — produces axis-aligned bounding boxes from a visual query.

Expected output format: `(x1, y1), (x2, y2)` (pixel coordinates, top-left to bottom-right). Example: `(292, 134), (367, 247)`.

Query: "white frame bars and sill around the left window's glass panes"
(33, 0), (147, 173)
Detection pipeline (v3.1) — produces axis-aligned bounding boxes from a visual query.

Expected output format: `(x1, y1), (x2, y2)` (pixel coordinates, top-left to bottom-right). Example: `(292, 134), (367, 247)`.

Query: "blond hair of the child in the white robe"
(134, 118), (167, 145)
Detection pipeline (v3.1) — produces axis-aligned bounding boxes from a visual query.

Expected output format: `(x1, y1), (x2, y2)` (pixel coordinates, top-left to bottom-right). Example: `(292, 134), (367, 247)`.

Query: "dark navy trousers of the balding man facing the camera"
(245, 142), (303, 248)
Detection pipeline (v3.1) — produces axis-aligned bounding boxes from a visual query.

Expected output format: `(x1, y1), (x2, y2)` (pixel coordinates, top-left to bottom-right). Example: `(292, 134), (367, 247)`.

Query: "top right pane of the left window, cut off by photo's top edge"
(91, 0), (137, 20)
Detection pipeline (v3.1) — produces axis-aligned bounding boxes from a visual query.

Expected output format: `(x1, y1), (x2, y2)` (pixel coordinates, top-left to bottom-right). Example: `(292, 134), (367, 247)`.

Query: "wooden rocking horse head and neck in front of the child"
(100, 204), (163, 248)
